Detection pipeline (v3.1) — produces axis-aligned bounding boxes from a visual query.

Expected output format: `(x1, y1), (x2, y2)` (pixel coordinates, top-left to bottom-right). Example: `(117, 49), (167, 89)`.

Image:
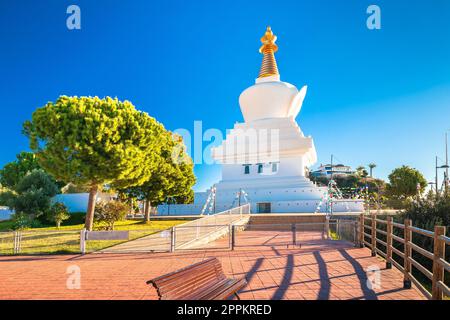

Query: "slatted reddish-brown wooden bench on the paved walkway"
(147, 258), (247, 300)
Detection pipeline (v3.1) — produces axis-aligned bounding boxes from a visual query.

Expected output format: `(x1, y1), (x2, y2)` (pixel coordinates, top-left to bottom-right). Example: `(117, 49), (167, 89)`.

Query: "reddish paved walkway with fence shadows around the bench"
(0, 231), (424, 300)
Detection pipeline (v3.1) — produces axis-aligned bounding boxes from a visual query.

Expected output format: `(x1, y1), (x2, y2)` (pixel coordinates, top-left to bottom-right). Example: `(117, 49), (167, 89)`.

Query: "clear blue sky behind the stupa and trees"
(0, 0), (450, 190)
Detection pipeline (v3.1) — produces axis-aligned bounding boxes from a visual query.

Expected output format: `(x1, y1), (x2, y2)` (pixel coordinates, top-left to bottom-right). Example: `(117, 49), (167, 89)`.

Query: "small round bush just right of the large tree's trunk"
(94, 201), (130, 230)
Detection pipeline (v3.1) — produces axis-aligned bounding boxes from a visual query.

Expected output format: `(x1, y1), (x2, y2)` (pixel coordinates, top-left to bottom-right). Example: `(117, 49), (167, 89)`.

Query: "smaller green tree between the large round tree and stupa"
(123, 132), (196, 222)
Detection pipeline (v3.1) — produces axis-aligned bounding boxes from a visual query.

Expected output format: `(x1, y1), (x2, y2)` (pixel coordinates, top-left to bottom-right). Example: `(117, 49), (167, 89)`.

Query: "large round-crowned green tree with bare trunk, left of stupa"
(24, 96), (165, 230)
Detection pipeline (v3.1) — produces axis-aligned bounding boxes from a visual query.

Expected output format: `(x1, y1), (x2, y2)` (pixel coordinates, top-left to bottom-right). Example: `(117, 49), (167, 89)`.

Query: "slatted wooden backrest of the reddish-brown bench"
(148, 258), (225, 300)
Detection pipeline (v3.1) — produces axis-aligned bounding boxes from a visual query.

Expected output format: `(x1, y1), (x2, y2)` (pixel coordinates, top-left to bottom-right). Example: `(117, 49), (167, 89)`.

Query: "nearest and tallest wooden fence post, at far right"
(431, 226), (445, 300)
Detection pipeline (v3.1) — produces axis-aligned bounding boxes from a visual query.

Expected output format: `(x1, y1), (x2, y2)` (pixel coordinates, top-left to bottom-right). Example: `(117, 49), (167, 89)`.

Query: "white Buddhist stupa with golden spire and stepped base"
(158, 27), (363, 214)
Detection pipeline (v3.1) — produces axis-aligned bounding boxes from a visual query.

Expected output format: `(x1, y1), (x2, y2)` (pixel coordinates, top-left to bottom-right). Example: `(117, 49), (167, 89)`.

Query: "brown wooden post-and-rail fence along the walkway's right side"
(358, 214), (450, 300)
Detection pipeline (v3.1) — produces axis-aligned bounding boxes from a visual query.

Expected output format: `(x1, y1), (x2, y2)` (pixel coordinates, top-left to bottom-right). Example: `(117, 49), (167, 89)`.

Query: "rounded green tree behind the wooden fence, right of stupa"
(387, 166), (427, 199)
